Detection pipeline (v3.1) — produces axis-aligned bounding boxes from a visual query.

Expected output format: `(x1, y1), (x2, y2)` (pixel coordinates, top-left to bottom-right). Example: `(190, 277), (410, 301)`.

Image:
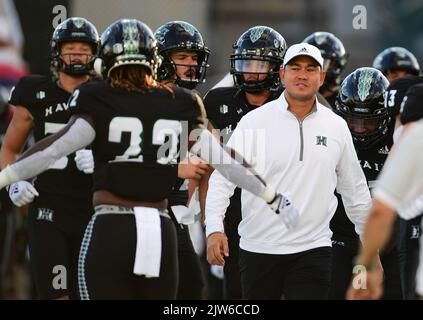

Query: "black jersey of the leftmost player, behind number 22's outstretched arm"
(9, 75), (92, 201)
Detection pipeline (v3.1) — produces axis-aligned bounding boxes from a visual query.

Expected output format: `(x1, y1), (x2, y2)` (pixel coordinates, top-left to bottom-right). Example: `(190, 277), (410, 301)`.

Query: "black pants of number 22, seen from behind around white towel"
(78, 214), (178, 299)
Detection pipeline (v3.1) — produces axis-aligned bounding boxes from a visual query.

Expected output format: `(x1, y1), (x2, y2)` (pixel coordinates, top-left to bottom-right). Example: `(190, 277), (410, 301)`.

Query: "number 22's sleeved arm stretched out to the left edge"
(0, 115), (95, 189)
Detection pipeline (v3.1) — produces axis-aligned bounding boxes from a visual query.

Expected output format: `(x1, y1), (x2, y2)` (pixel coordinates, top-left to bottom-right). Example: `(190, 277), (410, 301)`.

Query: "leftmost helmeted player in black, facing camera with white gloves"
(1, 17), (99, 299)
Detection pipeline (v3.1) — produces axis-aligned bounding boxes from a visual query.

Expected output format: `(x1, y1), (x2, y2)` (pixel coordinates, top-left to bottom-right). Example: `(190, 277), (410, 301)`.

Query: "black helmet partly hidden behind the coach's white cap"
(303, 31), (348, 92)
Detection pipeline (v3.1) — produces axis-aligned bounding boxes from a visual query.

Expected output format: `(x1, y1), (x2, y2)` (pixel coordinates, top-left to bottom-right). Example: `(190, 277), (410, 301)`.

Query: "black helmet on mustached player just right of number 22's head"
(154, 21), (210, 89)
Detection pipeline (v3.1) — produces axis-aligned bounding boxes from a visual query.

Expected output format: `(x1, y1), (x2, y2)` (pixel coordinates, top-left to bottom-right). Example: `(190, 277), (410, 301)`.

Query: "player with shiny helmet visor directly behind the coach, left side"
(201, 26), (287, 299)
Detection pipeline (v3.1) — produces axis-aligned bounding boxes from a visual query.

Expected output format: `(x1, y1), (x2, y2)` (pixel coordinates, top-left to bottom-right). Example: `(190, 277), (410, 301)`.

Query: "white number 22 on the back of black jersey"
(108, 117), (182, 164)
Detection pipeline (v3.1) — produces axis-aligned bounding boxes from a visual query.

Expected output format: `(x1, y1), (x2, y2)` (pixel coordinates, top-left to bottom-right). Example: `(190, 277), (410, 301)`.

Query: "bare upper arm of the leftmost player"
(0, 106), (34, 169)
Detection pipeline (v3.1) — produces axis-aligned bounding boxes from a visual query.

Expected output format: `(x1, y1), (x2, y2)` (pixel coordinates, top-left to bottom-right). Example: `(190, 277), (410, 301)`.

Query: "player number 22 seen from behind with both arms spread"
(0, 19), (298, 299)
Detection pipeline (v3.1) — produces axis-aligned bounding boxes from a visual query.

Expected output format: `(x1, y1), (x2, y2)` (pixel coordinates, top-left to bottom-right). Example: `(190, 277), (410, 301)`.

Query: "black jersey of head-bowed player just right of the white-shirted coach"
(330, 133), (393, 240)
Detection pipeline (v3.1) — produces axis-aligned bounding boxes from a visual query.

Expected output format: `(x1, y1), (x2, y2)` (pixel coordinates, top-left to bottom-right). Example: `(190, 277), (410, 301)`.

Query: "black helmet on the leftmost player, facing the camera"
(50, 17), (99, 76)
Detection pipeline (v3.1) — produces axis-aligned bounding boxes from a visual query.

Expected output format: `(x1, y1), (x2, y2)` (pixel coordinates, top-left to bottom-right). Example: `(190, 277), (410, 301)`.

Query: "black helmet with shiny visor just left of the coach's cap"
(231, 26), (287, 92)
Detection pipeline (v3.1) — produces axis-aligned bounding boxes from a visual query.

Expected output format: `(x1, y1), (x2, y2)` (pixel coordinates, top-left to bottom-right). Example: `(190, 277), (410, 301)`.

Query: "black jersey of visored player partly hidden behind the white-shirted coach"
(204, 87), (284, 226)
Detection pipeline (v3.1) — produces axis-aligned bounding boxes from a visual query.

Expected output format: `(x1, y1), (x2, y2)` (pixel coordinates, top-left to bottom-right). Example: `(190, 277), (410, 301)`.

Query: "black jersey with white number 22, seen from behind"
(69, 81), (203, 201)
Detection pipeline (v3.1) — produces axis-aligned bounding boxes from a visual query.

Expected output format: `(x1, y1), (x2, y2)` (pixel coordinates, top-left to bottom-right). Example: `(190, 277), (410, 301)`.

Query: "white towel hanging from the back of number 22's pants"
(134, 207), (162, 278)
